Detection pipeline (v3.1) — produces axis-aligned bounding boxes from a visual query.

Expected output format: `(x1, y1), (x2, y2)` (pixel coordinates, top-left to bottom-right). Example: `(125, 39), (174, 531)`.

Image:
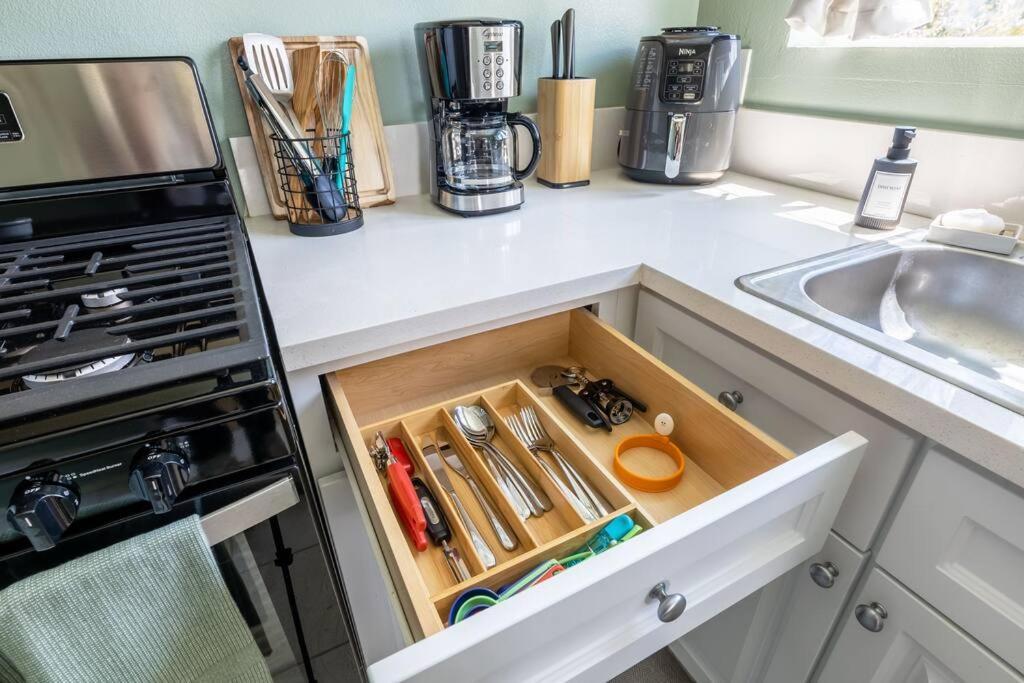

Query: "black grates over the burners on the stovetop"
(0, 217), (266, 419)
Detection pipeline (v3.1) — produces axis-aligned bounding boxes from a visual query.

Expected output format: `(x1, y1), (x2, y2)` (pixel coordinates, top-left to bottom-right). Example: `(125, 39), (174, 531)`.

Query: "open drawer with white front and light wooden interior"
(327, 309), (865, 682)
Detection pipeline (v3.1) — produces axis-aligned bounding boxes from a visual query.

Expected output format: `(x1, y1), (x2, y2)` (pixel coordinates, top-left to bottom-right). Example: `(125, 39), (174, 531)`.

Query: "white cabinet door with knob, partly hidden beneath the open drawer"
(672, 533), (865, 683)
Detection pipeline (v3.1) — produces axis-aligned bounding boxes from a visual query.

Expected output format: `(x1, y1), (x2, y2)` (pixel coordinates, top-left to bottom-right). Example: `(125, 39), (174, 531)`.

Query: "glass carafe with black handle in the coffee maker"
(440, 112), (541, 191)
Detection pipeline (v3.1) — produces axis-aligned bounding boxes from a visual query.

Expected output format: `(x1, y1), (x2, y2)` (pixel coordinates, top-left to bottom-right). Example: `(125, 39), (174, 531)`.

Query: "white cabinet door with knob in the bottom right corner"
(818, 569), (1024, 683)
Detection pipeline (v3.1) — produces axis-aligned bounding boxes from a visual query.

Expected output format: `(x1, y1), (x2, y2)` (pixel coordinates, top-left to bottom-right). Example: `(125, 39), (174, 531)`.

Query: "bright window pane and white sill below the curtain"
(790, 0), (1024, 47)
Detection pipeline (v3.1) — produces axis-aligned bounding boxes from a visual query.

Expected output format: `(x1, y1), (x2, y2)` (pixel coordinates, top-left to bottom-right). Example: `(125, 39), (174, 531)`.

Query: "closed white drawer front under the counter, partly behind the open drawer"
(636, 291), (918, 550)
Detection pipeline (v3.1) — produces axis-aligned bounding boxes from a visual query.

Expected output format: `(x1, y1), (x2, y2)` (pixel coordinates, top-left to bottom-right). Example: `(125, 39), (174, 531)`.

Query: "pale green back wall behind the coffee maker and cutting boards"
(0, 0), (697, 154)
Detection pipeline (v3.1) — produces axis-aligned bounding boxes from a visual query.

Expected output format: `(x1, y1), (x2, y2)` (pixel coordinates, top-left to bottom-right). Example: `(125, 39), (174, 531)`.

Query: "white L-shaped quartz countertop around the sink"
(246, 170), (1024, 486)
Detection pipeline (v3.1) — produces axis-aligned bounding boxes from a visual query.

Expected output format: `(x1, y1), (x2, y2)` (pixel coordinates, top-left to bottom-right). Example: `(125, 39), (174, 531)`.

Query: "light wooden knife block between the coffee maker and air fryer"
(537, 78), (597, 189)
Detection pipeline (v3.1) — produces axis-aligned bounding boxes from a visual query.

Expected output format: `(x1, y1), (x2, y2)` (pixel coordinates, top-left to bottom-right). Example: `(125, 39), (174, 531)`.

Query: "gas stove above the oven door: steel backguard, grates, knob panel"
(0, 59), (298, 561)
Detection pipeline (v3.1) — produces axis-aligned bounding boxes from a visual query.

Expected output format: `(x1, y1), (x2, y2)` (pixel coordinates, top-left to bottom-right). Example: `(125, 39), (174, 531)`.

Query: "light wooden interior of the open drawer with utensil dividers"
(327, 310), (793, 639)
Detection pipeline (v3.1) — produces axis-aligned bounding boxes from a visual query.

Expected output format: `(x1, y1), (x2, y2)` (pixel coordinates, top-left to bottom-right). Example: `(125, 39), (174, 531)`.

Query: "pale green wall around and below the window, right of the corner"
(699, 0), (1024, 137)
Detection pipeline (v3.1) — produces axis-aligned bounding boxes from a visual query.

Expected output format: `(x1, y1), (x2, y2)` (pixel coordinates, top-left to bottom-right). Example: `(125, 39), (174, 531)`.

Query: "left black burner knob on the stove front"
(7, 472), (81, 550)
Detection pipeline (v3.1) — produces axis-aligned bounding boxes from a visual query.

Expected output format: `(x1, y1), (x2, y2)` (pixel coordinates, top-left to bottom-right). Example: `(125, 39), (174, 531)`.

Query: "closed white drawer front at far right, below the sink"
(879, 449), (1024, 671)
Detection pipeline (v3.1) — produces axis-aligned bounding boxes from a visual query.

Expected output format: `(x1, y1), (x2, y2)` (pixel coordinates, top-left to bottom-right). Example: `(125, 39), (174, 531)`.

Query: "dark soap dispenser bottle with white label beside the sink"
(853, 126), (918, 230)
